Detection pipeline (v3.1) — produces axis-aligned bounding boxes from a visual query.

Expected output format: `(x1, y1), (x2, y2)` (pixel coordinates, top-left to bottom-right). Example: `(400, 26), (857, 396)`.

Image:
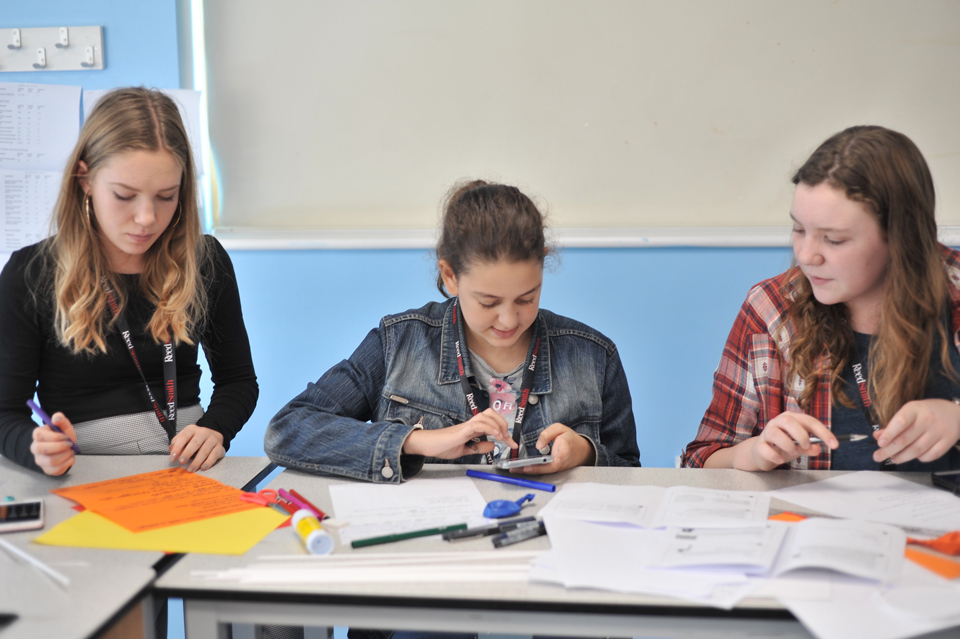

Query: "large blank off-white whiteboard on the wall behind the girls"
(204, 0), (960, 230)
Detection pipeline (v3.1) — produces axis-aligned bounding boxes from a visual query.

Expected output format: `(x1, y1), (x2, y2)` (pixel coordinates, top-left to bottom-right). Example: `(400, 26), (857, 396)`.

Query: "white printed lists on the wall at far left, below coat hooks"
(0, 83), (81, 253)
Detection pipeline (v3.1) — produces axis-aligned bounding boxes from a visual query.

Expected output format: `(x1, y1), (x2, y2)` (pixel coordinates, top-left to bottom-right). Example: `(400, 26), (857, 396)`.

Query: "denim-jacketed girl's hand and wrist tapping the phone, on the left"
(403, 408), (517, 459)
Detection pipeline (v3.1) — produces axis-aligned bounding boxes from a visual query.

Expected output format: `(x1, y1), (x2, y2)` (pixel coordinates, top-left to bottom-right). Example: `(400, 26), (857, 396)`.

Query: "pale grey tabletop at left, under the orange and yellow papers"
(0, 455), (272, 639)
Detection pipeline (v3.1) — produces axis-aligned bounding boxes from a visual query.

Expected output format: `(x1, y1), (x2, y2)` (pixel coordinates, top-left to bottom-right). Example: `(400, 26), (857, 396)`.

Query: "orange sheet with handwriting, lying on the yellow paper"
(50, 468), (262, 532)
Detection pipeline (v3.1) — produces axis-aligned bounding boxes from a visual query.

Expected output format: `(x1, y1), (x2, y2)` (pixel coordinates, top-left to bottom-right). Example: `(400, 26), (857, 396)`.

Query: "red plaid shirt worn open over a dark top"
(682, 247), (960, 470)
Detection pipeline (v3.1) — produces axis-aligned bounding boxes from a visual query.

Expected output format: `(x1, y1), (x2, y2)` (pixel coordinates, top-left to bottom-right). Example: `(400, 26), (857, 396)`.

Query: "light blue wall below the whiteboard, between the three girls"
(230, 248), (790, 466)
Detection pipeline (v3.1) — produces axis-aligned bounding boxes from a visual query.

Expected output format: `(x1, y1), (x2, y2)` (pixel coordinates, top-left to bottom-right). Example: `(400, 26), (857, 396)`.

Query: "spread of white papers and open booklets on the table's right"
(531, 480), (960, 639)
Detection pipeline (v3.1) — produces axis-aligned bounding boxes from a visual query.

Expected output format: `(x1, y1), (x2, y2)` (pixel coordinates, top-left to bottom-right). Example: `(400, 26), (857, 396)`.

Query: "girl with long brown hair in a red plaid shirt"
(683, 126), (960, 470)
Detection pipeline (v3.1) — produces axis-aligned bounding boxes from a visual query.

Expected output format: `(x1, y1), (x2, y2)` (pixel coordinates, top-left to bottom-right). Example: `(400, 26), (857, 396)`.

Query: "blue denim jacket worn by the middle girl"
(264, 300), (640, 483)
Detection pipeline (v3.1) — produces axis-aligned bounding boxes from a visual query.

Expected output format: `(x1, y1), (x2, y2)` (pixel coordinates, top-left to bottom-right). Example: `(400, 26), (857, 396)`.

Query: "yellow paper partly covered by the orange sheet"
(34, 508), (287, 555)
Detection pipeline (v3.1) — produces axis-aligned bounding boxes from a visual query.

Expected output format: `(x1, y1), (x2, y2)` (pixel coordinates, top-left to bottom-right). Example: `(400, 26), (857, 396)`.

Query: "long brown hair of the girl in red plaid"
(788, 126), (957, 426)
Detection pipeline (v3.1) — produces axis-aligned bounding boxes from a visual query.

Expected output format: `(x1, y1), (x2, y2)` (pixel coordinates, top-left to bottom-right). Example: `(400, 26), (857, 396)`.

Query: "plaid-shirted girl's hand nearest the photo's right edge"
(873, 399), (960, 464)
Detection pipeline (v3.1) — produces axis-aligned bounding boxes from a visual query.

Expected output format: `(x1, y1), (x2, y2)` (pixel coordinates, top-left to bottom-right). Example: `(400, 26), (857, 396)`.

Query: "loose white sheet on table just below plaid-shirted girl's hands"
(769, 470), (960, 533)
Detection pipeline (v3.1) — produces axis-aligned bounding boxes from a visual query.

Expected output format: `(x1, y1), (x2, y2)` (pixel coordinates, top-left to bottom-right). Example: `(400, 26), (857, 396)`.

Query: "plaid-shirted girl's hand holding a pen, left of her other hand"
(732, 407), (836, 470)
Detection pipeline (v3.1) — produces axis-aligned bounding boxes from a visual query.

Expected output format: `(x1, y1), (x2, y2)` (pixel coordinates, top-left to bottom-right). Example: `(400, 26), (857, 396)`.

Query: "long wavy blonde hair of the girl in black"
(40, 88), (210, 354)
